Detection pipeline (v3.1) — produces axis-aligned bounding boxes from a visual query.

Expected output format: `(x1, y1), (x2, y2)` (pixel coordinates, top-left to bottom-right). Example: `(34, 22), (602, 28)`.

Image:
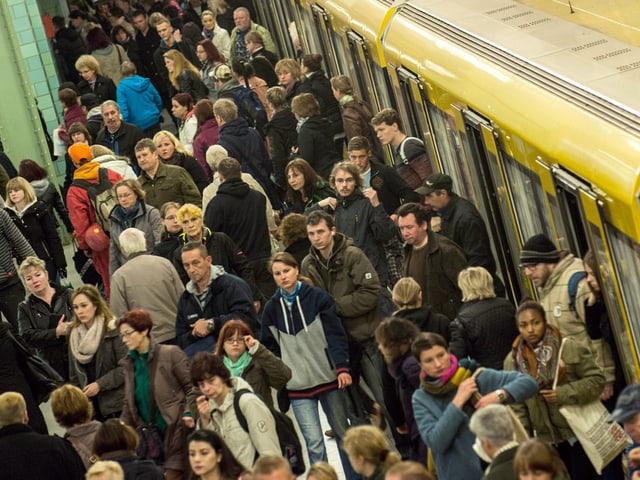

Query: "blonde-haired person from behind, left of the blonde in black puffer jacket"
(391, 277), (450, 341)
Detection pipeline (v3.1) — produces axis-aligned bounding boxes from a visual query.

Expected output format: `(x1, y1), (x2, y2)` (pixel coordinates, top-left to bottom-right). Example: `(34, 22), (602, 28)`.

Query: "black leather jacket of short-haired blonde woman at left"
(18, 285), (73, 380)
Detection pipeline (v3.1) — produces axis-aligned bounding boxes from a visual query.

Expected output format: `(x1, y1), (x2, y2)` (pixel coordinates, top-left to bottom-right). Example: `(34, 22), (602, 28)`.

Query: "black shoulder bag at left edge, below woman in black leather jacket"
(7, 329), (64, 405)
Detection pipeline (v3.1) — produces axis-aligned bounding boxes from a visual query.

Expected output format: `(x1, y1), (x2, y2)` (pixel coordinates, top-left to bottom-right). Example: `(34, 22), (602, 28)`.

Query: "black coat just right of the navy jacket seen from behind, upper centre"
(265, 107), (298, 189)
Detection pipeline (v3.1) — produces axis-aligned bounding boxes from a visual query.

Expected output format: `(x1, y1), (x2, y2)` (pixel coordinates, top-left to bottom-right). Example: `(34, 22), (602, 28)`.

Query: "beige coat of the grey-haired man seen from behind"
(109, 254), (184, 343)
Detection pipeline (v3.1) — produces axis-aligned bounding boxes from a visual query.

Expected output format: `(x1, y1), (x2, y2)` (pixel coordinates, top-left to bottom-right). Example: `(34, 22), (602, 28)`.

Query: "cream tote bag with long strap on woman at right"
(553, 338), (631, 475)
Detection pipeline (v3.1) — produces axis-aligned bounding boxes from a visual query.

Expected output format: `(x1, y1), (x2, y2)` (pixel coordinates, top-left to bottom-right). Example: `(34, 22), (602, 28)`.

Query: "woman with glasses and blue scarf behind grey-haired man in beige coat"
(109, 180), (162, 275)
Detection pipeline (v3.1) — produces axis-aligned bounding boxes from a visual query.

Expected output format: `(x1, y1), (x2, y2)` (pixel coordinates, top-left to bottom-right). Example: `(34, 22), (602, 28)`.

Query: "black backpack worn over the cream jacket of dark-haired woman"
(233, 388), (307, 475)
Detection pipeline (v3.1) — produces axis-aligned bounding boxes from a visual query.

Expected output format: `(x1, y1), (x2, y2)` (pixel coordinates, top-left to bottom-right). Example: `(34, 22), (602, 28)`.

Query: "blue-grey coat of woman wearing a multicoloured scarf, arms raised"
(412, 368), (538, 480)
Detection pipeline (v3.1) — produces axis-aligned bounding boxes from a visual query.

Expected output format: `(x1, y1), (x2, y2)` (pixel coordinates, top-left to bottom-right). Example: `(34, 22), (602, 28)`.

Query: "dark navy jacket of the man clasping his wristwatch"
(176, 265), (256, 349)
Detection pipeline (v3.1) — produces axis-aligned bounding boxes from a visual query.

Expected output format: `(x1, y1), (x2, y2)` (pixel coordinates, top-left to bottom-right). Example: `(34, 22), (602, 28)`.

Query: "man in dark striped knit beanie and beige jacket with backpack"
(520, 233), (615, 400)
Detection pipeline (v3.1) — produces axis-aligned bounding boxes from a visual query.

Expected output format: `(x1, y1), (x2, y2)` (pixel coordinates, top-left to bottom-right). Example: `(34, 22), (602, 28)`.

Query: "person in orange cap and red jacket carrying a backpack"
(67, 143), (122, 298)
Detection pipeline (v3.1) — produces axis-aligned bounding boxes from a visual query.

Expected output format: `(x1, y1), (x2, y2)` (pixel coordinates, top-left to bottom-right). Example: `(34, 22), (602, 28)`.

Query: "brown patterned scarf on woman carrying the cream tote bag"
(512, 325), (562, 389)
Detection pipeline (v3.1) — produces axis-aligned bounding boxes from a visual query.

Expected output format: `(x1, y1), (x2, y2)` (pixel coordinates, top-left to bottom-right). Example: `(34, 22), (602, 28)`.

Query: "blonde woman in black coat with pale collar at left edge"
(4, 177), (67, 282)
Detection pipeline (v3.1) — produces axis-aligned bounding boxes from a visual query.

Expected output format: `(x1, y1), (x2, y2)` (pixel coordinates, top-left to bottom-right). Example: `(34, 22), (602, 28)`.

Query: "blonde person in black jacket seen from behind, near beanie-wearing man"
(449, 267), (518, 370)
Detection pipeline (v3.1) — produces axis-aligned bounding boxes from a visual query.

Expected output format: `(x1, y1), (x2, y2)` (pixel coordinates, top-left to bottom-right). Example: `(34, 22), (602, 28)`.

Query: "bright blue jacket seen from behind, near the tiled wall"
(116, 75), (162, 130)
